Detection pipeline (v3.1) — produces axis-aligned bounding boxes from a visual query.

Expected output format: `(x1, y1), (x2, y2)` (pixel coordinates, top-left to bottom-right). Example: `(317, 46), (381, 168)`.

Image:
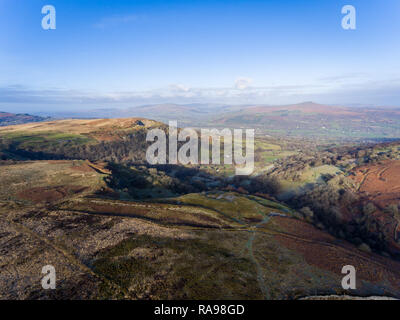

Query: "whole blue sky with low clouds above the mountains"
(0, 0), (400, 113)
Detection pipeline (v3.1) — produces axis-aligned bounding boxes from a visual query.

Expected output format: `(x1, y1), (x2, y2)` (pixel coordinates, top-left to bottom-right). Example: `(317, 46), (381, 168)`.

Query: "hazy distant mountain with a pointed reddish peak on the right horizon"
(208, 102), (400, 139)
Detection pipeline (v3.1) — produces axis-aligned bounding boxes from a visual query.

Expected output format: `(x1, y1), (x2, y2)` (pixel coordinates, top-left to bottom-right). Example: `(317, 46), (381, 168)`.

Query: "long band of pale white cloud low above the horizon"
(0, 78), (400, 110)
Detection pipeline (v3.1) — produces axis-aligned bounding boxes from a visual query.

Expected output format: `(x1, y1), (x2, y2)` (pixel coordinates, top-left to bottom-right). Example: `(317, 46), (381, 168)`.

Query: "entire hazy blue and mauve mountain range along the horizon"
(9, 102), (400, 139)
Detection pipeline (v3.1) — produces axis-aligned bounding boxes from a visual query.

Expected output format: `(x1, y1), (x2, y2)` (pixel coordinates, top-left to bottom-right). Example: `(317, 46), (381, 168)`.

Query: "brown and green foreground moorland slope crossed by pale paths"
(0, 161), (400, 299)
